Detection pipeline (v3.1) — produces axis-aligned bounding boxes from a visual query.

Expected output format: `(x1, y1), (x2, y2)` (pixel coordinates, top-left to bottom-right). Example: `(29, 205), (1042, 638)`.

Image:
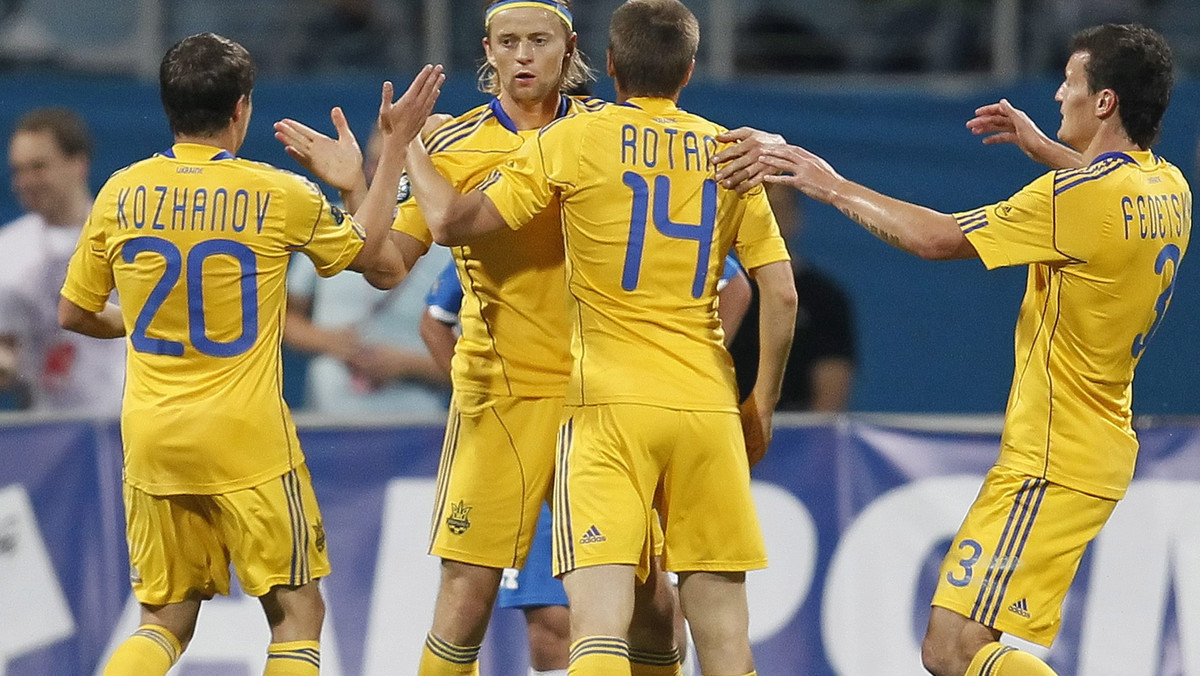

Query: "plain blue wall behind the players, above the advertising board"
(0, 72), (1200, 414)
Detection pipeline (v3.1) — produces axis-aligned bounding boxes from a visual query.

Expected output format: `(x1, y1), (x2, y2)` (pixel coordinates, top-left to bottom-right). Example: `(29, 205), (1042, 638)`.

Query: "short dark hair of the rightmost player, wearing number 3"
(1070, 24), (1175, 149)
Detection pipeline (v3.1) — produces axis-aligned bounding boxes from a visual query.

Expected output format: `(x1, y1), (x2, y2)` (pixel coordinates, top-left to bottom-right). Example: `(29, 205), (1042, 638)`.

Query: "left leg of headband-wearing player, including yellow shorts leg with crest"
(418, 393), (563, 676)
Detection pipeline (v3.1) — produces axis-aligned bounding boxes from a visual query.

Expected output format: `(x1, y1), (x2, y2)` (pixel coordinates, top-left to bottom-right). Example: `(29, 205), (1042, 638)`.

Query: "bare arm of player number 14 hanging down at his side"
(742, 261), (797, 465)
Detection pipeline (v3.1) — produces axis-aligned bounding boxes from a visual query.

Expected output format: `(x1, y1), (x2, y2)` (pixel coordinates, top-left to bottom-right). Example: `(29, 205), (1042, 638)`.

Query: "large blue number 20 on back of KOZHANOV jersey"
(121, 237), (258, 357)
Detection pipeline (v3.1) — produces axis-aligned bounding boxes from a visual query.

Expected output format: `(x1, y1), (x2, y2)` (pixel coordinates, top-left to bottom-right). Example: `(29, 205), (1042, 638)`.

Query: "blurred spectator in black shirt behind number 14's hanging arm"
(730, 185), (856, 411)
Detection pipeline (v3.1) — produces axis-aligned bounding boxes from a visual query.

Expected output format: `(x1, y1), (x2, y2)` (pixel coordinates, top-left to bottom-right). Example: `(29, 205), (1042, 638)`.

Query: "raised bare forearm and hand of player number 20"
(349, 66), (445, 281)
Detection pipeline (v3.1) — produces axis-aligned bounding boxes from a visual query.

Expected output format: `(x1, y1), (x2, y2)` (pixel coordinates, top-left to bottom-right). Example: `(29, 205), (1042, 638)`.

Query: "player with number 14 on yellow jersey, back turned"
(396, 0), (796, 676)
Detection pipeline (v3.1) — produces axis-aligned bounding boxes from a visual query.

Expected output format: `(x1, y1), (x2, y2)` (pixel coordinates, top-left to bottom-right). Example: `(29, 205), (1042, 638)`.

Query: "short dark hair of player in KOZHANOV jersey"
(158, 32), (254, 136)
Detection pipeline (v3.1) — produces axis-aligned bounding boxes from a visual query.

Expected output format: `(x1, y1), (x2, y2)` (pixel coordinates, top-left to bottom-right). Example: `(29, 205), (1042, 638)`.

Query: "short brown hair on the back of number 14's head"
(608, 0), (700, 97)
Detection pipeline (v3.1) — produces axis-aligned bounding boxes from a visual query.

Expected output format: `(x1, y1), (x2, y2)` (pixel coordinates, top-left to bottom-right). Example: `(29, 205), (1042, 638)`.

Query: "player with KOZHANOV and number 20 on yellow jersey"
(59, 34), (443, 676)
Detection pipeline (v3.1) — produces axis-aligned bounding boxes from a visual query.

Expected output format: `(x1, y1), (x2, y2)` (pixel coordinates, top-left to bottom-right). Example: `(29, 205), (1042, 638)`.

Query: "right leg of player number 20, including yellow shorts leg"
(214, 465), (330, 676)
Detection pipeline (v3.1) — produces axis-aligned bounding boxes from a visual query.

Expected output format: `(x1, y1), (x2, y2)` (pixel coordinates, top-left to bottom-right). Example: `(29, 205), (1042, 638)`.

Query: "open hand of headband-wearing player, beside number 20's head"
(275, 108), (366, 192)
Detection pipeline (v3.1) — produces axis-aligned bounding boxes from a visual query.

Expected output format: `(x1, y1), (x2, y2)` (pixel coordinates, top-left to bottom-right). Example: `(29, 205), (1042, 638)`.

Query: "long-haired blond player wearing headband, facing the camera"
(277, 0), (678, 676)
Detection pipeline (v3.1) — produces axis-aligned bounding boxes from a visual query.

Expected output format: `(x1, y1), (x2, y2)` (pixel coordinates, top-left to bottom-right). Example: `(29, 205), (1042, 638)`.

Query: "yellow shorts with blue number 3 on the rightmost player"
(932, 466), (1116, 646)
